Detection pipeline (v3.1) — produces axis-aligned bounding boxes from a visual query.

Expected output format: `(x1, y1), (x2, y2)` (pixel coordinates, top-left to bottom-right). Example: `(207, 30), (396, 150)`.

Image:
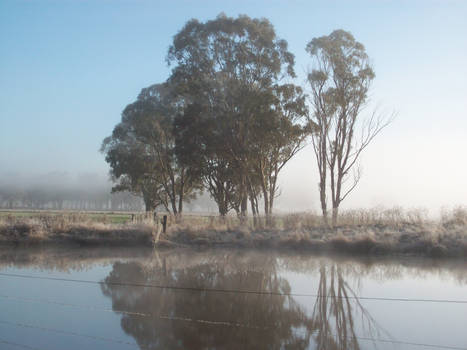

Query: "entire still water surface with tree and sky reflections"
(0, 248), (467, 350)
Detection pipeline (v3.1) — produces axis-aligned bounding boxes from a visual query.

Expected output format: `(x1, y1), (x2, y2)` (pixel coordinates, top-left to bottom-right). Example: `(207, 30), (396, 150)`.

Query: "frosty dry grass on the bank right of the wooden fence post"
(168, 207), (467, 257)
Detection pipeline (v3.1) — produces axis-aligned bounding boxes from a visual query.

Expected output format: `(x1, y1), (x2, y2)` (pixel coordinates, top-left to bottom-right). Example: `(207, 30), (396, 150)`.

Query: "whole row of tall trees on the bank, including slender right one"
(101, 14), (392, 223)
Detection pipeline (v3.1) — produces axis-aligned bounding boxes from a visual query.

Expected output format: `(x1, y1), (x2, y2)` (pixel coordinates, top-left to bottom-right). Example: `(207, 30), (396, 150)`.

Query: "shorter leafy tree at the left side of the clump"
(101, 84), (198, 214)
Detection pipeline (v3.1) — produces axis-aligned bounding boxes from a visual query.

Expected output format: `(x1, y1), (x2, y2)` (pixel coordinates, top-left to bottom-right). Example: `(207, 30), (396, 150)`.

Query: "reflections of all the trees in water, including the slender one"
(102, 254), (392, 350)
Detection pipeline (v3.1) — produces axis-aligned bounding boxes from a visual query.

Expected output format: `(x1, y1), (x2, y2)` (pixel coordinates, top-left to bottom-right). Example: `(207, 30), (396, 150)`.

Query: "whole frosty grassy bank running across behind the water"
(0, 209), (467, 258)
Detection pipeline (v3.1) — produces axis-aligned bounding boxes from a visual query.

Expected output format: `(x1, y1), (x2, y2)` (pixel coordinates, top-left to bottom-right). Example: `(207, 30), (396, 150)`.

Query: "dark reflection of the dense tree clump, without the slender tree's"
(102, 253), (309, 349)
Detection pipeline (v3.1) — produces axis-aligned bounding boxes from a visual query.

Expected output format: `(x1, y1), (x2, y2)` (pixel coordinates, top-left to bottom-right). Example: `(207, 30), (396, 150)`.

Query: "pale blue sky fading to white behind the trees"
(0, 0), (467, 208)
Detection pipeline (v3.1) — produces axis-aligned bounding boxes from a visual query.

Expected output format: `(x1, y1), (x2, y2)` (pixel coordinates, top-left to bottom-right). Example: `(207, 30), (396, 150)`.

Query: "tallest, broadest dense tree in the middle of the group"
(167, 15), (306, 215)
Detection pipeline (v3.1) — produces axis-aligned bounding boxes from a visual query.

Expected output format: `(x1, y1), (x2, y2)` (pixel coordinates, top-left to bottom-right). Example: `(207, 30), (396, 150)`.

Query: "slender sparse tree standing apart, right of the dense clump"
(306, 30), (392, 226)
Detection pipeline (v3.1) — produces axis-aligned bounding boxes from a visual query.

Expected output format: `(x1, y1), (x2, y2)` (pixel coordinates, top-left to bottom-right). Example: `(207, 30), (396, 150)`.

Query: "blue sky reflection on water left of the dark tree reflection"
(0, 265), (135, 350)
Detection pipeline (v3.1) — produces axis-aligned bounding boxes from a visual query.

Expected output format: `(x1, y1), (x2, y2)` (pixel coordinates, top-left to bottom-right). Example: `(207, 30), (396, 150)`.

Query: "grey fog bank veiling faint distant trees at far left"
(0, 171), (217, 213)
